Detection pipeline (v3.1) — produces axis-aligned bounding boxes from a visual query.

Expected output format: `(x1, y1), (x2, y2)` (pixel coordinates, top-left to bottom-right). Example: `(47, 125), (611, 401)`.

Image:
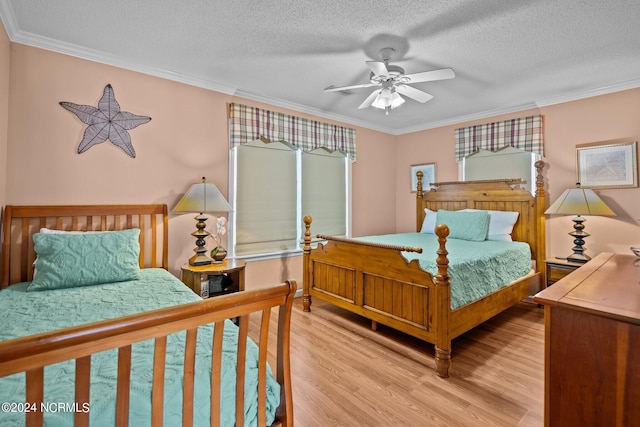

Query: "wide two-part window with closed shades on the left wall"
(230, 140), (351, 257)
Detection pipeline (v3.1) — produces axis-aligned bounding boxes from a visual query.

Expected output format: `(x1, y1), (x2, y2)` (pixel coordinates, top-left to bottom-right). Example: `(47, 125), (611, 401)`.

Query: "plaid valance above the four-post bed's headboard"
(456, 115), (544, 161)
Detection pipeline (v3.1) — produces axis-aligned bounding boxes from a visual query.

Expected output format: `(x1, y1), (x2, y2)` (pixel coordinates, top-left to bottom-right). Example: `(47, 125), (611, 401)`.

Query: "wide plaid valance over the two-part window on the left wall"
(229, 103), (356, 160)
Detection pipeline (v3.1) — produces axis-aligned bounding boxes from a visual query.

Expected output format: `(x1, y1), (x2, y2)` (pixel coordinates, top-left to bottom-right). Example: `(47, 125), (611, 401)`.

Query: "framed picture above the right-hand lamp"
(576, 139), (638, 188)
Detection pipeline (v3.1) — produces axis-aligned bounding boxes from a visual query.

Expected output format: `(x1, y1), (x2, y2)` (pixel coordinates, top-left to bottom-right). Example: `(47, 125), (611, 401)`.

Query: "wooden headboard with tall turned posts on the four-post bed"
(416, 161), (546, 271)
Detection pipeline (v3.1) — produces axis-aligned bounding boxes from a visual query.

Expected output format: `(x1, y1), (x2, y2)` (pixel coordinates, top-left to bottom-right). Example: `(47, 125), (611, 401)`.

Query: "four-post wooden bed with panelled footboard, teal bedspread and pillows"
(302, 161), (545, 377)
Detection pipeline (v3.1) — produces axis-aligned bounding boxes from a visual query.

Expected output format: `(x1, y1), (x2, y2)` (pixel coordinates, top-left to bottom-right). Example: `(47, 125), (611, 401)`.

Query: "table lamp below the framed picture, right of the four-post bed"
(544, 183), (616, 263)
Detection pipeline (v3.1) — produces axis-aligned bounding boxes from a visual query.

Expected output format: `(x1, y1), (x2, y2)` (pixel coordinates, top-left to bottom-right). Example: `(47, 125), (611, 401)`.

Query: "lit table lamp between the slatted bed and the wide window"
(173, 177), (231, 265)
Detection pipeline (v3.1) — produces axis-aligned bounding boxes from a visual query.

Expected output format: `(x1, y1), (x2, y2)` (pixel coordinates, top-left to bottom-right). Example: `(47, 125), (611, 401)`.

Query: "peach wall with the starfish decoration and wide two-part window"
(6, 43), (395, 285)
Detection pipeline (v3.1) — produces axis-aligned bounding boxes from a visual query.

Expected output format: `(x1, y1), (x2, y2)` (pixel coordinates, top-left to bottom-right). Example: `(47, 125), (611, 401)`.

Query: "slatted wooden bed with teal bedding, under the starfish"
(0, 205), (296, 426)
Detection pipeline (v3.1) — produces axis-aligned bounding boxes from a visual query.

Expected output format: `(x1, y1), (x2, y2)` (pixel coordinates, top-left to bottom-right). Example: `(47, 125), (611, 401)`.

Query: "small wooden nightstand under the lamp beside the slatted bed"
(182, 259), (246, 298)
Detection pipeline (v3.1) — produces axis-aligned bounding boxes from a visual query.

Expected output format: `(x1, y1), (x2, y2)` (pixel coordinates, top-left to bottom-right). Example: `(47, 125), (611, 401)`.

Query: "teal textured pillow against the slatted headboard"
(27, 229), (140, 291)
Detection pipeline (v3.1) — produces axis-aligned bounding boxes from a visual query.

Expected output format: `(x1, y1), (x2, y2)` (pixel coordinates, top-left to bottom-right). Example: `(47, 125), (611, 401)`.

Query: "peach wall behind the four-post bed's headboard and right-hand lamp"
(396, 89), (640, 257)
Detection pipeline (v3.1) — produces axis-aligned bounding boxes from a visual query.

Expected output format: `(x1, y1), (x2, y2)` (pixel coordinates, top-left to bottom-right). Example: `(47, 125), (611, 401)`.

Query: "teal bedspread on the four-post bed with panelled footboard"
(358, 233), (531, 310)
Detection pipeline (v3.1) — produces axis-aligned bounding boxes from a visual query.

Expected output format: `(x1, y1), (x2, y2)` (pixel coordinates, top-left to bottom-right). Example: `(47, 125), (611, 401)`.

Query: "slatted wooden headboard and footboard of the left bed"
(0, 205), (296, 427)
